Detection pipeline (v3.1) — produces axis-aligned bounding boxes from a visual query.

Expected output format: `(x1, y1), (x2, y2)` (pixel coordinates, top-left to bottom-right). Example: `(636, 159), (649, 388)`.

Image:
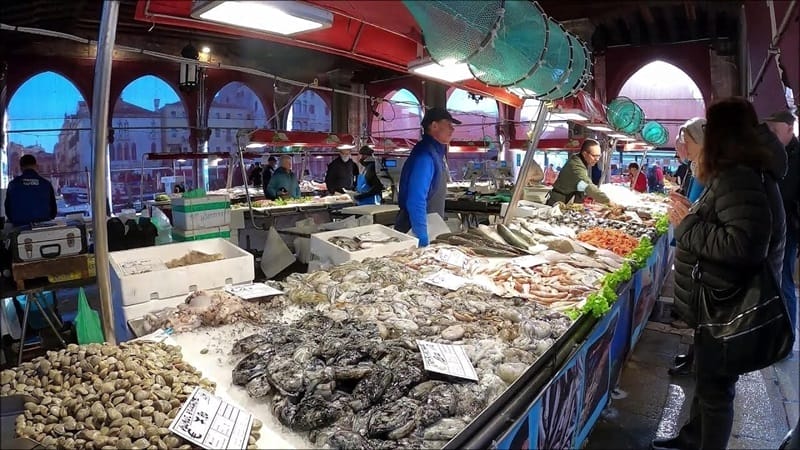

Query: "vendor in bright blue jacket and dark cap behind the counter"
(395, 108), (461, 247)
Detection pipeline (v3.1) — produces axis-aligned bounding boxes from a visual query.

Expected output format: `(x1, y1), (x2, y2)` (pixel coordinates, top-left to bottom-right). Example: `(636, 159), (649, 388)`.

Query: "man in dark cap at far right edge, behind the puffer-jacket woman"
(764, 111), (800, 329)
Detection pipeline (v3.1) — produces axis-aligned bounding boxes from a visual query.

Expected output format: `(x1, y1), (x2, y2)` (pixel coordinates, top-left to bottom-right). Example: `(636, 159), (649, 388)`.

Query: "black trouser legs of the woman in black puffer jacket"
(678, 354), (739, 450)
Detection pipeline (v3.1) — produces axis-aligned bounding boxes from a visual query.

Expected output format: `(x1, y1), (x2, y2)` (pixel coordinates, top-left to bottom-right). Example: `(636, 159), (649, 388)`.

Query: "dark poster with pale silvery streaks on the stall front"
(535, 352), (584, 448)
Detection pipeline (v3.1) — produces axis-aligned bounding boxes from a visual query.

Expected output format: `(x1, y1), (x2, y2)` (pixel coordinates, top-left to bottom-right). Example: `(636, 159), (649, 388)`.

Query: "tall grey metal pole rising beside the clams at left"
(92, 0), (119, 344)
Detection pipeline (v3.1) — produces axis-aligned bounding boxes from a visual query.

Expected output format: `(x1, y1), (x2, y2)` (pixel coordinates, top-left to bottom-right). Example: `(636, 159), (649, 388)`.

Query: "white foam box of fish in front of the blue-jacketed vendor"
(311, 224), (419, 264)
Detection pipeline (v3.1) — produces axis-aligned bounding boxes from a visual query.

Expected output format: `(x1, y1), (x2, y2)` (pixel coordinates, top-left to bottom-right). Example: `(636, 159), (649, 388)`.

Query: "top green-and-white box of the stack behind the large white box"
(172, 195), (231, 230)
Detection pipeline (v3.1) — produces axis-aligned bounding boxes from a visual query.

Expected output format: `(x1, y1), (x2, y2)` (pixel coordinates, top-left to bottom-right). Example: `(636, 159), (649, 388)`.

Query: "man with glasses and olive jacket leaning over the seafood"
(547, 139), (610, 205)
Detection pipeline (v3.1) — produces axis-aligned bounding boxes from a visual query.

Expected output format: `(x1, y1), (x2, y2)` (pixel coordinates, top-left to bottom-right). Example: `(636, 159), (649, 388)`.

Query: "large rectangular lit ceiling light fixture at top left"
(192, 0), (333, 36)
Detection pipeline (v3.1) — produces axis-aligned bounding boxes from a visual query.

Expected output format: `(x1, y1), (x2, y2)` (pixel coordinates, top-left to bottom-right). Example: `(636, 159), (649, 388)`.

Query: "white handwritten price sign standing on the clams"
(169, 386), (253, 450)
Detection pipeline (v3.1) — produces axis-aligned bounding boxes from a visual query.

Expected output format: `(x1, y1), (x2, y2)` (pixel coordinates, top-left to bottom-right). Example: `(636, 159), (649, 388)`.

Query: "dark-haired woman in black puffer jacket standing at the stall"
(652, 98), (786, 450)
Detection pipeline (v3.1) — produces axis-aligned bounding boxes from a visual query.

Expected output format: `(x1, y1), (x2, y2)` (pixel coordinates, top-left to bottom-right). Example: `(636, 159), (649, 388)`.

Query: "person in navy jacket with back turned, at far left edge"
(5, 155), (58, 226)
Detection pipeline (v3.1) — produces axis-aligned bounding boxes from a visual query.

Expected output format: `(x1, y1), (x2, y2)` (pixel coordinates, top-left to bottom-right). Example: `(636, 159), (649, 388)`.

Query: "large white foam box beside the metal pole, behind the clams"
(108, 238), (255, 306)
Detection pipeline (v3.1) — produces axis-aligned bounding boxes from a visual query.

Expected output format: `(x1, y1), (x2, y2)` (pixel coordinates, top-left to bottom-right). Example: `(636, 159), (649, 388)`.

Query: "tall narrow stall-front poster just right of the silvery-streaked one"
(572, 308), (620, 448)
